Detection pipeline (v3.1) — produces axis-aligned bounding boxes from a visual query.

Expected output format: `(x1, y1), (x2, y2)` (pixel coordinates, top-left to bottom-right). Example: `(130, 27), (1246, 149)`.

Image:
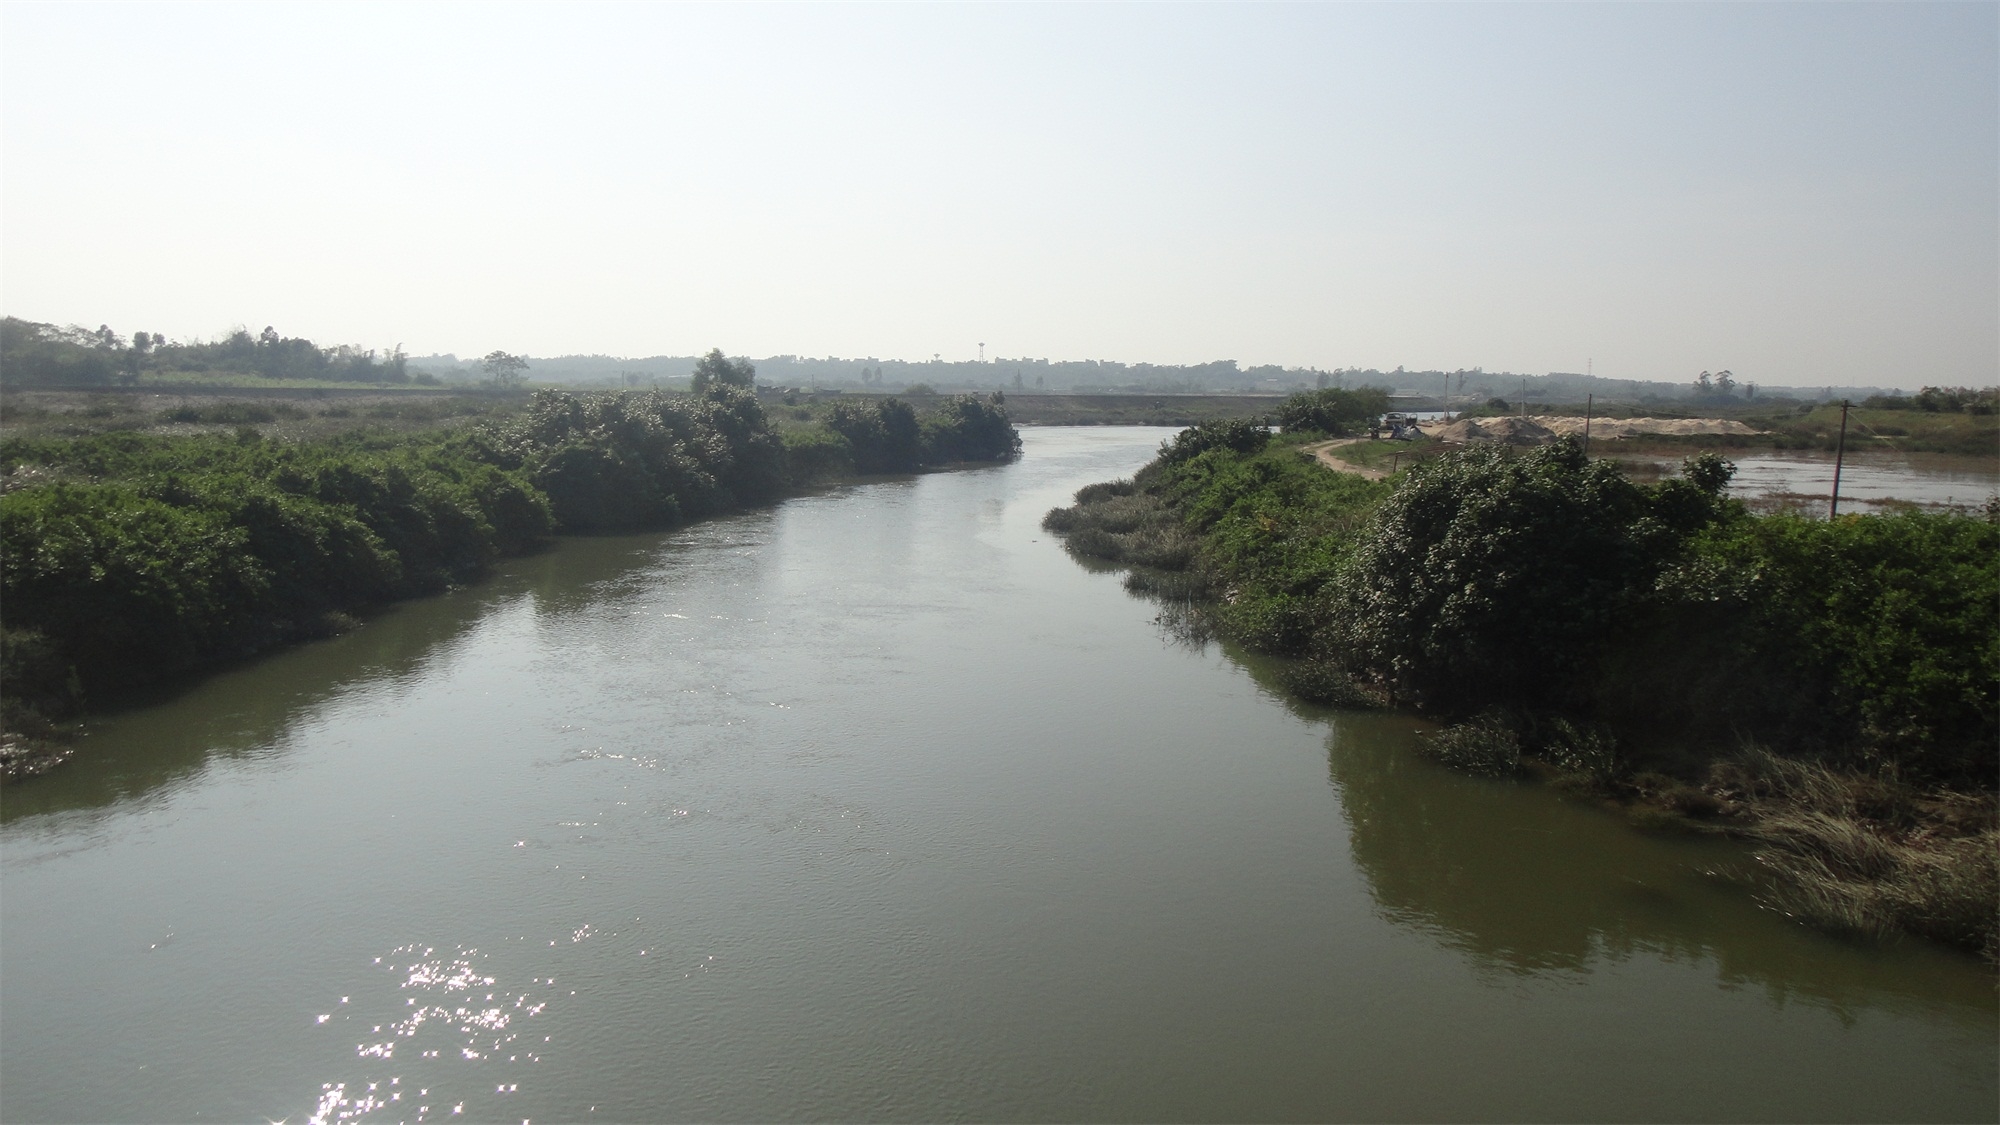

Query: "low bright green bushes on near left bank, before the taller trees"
(0, 434), (550, 705)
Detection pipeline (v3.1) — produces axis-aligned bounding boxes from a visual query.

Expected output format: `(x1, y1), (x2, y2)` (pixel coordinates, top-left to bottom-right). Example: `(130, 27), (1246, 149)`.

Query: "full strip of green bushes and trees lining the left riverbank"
(0, 374), (1018, 729)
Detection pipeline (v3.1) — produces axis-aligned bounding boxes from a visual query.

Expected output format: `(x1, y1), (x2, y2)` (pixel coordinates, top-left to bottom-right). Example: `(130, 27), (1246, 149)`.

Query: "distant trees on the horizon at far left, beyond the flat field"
(0, 316), (436, 386)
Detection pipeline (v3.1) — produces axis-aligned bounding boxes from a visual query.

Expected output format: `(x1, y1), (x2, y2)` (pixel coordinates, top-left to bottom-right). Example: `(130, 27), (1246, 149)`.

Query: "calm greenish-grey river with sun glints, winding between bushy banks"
(0, 428), (2000, 1123)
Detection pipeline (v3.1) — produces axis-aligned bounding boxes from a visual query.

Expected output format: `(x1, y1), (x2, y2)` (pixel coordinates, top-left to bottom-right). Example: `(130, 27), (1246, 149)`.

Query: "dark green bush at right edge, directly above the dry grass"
(1656, 512), (2000, 783)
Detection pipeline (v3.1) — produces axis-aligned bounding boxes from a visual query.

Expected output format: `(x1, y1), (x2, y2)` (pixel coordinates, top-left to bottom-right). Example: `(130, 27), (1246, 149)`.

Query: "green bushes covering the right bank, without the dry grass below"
(1046, 398), (2000, 785)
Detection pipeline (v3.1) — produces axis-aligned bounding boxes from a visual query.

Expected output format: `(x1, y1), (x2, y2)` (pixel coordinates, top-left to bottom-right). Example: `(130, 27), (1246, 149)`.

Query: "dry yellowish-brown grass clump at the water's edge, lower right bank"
(1714, 749), (2000, 961)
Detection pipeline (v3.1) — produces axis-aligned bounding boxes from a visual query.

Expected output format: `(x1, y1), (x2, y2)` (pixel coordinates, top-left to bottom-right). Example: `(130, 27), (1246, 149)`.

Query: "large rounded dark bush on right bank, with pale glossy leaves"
(1334, 440), (1728, 715)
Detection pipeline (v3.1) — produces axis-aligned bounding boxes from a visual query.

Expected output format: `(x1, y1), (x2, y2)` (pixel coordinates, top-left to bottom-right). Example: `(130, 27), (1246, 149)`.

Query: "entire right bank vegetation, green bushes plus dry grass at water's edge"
(1046, 390), (2000, 959)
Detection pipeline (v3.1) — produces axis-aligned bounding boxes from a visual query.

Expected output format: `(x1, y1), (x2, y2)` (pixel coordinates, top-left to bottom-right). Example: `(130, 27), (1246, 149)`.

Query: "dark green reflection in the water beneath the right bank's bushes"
(1226, 649), (2000, 1019)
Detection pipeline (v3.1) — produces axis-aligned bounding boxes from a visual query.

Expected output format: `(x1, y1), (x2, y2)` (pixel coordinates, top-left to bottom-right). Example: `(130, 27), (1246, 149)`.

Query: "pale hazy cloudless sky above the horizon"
(0, 2), (2000, 386)
